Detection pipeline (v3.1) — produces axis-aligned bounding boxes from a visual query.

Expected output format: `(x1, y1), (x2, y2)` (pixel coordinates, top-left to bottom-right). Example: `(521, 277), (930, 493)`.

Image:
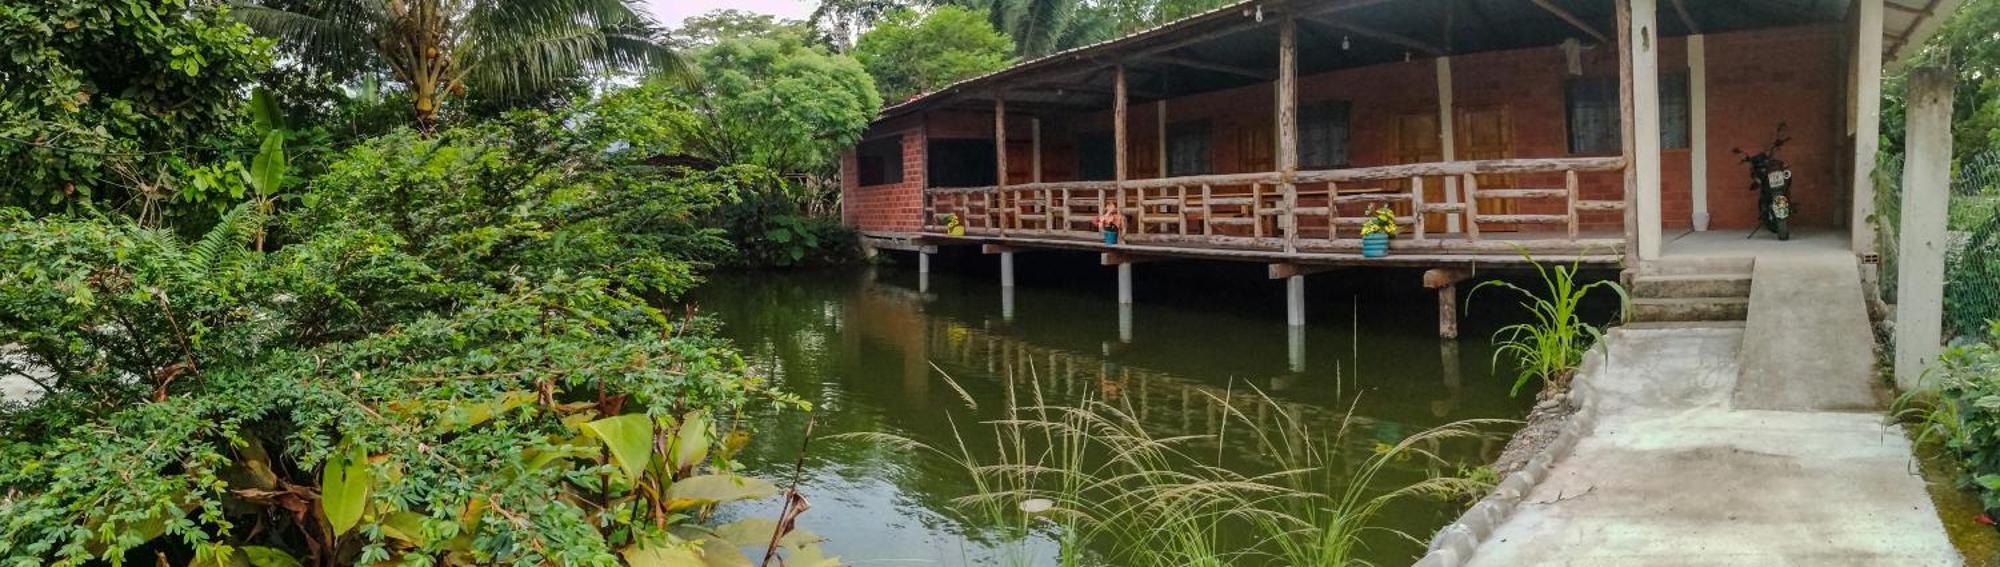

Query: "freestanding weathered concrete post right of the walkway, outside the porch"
(1896, 68), (1956, 391)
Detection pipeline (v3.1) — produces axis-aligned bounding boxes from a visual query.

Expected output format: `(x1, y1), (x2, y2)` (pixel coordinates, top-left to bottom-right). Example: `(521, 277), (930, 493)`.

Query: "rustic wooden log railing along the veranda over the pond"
(924, 158), (1626, 252)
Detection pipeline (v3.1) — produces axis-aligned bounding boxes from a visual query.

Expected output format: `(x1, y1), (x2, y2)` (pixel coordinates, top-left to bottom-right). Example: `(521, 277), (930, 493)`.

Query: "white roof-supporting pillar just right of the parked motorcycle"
(1848, 0), (1880, 254)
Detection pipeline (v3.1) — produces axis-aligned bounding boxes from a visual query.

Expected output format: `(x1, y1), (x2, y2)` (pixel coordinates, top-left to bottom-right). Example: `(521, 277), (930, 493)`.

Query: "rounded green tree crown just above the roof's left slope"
(854, 6), (1014, 102)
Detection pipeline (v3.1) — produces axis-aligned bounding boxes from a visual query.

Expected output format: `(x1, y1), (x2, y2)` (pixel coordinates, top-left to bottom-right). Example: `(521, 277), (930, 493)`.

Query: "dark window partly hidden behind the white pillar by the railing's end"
(1564, 74), (1690, 156)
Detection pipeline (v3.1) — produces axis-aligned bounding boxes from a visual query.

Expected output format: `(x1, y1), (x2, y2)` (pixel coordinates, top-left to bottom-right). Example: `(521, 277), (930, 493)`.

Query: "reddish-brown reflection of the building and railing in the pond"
(844, 277), (1496, 461)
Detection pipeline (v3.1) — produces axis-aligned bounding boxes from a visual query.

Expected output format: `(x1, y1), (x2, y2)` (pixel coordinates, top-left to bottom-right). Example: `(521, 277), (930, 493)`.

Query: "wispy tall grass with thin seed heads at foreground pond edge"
(832, 369), (1500, 567)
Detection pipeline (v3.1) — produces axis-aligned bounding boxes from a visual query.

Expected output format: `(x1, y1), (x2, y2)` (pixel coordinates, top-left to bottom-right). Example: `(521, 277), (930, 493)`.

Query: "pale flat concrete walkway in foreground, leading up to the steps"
(1468, 323), (1962, 565)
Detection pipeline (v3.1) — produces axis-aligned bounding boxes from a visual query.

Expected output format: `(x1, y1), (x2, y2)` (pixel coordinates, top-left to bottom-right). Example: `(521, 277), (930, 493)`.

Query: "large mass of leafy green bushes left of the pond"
(0, 141), (828, 565)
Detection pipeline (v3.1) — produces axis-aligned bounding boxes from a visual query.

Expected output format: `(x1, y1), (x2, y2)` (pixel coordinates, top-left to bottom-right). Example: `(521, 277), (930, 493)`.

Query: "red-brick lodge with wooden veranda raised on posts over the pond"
(842, 0), (1952, 327)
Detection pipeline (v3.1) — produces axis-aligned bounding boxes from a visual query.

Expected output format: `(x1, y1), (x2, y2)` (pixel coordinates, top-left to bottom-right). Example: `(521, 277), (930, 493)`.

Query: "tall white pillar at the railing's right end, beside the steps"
(1624, 0), (1660, 260)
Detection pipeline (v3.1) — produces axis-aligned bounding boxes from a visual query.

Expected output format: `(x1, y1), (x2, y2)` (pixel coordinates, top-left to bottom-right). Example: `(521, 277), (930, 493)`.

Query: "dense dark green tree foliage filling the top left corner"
(0, 0), (270, 214)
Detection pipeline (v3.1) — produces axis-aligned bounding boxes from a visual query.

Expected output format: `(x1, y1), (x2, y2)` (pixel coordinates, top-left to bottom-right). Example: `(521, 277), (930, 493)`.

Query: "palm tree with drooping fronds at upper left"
(232, 0), (682, 130)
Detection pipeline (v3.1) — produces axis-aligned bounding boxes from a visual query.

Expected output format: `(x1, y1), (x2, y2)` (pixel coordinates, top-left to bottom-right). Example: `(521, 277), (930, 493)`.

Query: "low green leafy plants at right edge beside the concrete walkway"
(1896, 321), (2000, 511)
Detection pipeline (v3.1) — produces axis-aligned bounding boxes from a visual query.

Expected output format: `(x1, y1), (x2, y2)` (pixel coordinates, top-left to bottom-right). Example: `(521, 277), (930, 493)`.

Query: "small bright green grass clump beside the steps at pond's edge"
(1466, 252), (1632, 397)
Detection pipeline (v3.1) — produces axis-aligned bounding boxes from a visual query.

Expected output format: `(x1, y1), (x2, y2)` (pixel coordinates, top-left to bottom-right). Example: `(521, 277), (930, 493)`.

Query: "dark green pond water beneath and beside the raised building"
(690, 256), (1530, 565)
